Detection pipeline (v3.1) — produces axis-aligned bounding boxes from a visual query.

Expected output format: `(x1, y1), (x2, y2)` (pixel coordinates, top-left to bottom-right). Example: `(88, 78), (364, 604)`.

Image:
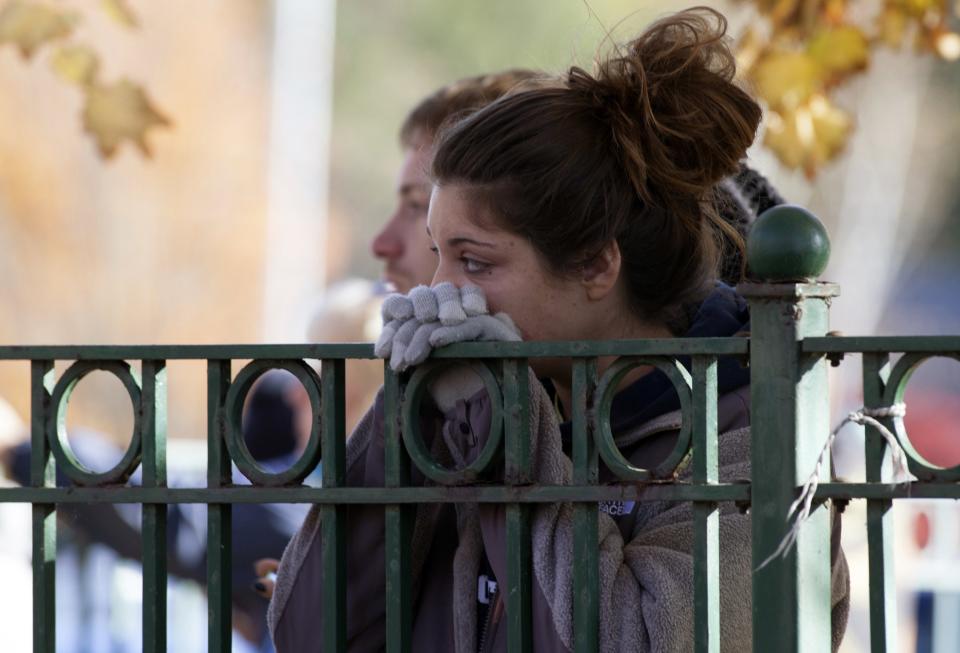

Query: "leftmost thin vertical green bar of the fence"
(30, 360), (57, 653)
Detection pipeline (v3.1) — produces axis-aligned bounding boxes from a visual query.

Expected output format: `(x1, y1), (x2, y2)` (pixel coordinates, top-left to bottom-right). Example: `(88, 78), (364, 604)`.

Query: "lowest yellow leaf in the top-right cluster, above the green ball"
(764, 94), (851, 178)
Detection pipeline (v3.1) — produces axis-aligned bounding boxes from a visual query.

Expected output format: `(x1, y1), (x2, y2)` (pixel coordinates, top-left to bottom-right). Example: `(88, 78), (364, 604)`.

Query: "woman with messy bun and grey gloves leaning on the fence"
(271, 9), (847, 653)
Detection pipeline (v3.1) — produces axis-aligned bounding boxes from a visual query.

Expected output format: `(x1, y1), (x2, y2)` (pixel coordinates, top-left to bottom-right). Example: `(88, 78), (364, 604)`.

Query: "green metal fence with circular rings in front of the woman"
(0, 210), (960, 653)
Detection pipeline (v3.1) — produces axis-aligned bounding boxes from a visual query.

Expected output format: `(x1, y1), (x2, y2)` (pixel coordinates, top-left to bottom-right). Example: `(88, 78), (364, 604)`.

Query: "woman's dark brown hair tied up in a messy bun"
(433, 7), (761, 325)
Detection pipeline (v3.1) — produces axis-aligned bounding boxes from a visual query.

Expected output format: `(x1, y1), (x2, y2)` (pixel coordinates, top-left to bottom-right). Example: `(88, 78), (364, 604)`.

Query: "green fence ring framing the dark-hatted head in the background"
(224, 359), (321, 487)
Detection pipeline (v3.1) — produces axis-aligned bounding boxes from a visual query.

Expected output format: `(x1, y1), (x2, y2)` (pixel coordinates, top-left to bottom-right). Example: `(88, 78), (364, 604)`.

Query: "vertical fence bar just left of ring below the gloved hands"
(383, 362), (415, 653)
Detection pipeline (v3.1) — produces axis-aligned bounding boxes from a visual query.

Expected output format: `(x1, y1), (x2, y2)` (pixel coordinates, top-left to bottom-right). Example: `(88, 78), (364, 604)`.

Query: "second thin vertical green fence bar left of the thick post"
(571, 358), (609, 653)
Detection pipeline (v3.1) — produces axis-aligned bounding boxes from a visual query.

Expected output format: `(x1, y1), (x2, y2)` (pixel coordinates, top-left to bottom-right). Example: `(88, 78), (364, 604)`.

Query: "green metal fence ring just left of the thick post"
(594, 357), (693, 481)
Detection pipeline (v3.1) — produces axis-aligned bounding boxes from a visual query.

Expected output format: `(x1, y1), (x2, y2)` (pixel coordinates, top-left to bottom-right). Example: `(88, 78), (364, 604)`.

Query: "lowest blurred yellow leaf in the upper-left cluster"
(83, 79), (170, 158)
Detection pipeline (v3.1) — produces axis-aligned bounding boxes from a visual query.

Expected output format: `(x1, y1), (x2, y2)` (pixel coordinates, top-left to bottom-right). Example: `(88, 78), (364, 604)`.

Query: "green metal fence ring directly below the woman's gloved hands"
(401, 360), (503, 485)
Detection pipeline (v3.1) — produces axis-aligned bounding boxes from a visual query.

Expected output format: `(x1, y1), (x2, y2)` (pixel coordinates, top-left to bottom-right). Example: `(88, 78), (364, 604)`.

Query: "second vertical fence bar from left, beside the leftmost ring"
(140, 360), (167, 653)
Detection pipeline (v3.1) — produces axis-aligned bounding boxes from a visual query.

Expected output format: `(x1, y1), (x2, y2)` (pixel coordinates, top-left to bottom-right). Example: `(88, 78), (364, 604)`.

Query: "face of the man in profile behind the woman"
(370, 141), (437, 293)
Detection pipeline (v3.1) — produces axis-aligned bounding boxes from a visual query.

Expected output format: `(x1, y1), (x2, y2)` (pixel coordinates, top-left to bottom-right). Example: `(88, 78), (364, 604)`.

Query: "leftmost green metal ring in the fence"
(47, 361), (143, 486)
